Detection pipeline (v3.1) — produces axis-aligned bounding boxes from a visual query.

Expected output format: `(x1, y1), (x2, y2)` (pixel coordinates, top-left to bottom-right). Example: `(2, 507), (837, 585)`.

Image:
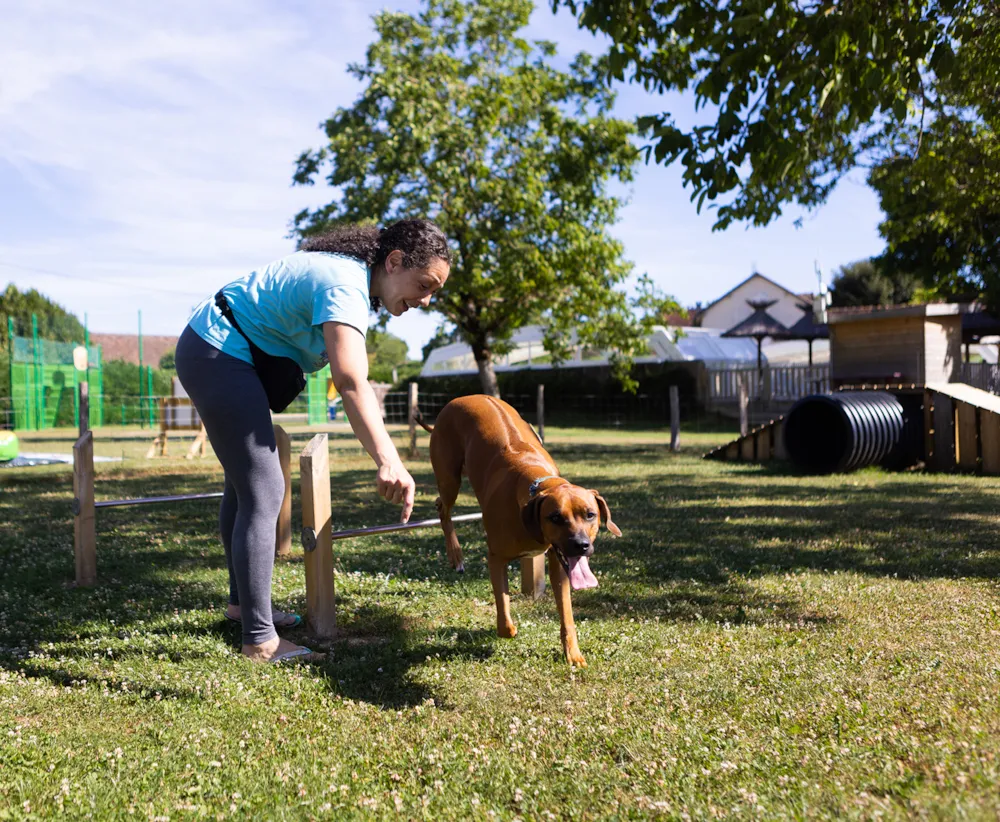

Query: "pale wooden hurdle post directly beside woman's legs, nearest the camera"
(299, 434), (337, 639)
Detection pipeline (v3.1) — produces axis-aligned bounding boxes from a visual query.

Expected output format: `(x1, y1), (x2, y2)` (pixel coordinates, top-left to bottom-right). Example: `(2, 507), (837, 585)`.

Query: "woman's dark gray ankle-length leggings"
(176, 326), (285, 645)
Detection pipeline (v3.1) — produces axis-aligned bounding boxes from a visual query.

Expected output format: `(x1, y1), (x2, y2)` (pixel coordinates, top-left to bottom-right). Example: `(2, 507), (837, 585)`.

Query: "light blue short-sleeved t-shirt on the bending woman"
(188, 251), (370, 372)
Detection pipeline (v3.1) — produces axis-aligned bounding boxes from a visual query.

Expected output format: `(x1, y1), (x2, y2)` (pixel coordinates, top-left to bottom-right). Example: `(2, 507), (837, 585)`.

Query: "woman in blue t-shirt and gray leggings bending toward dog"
(177, 220), (450, 662)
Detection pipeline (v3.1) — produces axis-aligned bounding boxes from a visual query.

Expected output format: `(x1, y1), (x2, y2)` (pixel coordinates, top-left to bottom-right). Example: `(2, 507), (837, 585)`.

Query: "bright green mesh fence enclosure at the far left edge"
(10, 337), (104, 431)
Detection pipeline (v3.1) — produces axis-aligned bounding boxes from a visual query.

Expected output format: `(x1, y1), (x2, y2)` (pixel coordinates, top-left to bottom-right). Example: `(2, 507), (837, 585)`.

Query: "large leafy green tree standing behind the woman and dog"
(294, 0), (676, 394)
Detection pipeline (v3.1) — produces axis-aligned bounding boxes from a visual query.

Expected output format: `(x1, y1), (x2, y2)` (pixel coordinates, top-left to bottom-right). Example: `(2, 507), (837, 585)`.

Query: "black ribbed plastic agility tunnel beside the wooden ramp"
(784, 391), (921, 474)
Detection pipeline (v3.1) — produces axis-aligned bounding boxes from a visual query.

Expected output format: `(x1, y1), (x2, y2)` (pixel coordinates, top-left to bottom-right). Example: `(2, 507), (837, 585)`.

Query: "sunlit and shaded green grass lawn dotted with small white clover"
(0, 428), (1000, 820)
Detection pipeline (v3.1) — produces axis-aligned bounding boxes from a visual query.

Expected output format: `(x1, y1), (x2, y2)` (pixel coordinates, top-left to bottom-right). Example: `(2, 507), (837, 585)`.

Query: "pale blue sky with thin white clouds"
(0, 0), (883, 355)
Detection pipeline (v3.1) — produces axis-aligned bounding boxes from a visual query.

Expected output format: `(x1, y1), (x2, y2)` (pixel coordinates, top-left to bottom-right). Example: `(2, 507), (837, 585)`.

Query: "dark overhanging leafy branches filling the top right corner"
(551, 0), (1000, 228)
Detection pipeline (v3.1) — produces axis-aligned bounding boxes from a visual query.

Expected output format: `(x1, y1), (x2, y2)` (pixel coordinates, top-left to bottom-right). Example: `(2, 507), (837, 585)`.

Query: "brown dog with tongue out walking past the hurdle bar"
(418, 395), (622, 668)
